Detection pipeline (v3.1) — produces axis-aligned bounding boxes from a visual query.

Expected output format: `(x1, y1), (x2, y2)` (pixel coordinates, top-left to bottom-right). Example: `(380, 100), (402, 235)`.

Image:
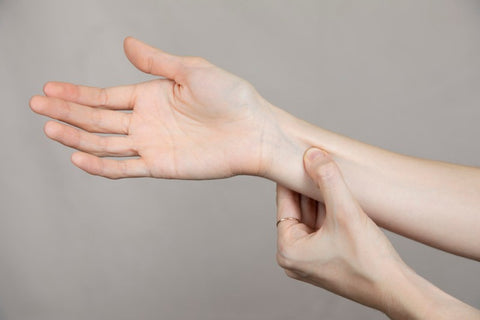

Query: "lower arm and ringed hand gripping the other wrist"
(277, 148), (480, 319)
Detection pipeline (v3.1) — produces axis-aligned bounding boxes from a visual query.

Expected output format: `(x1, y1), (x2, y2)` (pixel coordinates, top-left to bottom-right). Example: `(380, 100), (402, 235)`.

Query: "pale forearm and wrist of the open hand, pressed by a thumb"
(264, 107), (480, 260)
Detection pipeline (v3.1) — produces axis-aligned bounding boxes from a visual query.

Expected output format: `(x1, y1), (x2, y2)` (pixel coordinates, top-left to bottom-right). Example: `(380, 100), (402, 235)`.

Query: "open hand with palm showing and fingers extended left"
(30, 38), (272, 179)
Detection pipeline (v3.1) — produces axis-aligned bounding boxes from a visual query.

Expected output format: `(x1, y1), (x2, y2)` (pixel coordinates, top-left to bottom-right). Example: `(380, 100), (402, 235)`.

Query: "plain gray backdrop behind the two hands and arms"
(0, 0), (480, 320)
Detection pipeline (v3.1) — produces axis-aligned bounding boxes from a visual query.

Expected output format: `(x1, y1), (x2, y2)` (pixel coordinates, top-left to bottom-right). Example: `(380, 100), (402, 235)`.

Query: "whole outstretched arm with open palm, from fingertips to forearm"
(30, 38), (480, 318)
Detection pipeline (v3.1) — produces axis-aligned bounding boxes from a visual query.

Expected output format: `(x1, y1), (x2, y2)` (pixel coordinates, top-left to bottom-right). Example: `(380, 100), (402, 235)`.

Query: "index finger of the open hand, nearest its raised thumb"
(43, 82), (136, 110)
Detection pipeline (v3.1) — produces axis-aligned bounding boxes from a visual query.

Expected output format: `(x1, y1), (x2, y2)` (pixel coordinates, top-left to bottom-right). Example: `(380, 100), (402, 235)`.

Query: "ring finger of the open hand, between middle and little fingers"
(45, 121), (137, 157)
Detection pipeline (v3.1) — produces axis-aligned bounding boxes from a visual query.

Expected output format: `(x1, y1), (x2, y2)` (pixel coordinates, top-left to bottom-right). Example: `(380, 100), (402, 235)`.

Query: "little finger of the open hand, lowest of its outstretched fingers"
(72, 152), (150, 179)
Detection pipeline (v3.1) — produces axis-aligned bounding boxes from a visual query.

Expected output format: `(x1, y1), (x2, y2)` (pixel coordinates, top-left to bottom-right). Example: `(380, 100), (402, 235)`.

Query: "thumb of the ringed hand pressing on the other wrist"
(303, 148), (359, 216)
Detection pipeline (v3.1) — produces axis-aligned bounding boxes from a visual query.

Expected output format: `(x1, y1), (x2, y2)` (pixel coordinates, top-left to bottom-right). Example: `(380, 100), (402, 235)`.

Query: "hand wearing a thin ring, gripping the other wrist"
(277, 148), (405, 311)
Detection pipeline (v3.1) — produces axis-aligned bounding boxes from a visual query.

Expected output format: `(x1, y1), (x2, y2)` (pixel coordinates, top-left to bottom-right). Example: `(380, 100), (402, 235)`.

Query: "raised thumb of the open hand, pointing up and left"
(123, 37), (182, 82)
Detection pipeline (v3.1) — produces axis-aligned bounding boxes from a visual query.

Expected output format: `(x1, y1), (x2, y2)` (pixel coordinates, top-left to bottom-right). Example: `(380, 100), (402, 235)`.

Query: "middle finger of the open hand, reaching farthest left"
(30, 96), (130, 134)
